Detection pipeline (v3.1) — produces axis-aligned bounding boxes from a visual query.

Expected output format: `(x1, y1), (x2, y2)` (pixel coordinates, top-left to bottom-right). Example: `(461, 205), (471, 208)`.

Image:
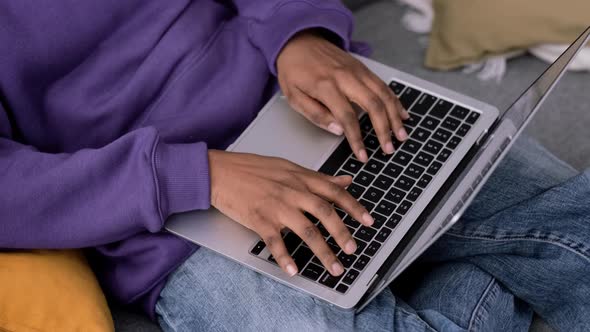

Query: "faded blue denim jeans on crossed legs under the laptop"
(156, 138), (590, 331)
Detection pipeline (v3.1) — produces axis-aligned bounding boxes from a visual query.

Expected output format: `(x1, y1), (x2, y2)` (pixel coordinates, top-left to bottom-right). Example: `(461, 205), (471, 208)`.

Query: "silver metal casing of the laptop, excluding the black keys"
(165, 28), (590, 310)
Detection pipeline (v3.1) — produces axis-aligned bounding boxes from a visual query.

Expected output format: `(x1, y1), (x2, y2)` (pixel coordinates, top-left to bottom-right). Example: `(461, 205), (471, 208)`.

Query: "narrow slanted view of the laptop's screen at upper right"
(502, 27), (590, 132)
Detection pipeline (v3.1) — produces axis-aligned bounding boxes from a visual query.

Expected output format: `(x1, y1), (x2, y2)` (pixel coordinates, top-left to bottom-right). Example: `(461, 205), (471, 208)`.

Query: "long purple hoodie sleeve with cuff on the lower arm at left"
(0, 105), (210, 249)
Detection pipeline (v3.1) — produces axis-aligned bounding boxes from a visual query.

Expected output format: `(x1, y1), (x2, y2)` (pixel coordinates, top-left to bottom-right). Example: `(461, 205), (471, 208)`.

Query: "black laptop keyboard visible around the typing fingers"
(250, 81), (480, 293)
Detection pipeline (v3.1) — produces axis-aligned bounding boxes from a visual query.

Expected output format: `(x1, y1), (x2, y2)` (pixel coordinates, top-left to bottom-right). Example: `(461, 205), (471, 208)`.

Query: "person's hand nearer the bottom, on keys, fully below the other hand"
(209, 150), (373, 276)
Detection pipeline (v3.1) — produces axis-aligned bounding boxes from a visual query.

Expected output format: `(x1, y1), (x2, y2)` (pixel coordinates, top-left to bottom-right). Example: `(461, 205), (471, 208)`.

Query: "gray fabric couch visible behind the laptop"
(111, 0), (590, 332)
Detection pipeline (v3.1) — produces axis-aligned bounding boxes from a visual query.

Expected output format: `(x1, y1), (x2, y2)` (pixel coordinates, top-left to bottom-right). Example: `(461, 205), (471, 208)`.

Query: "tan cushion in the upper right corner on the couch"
(426, 0), (590, 69)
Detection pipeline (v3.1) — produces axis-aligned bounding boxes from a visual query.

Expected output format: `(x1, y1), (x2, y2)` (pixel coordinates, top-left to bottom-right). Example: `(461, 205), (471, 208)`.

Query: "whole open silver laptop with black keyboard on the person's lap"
(165, 28), (590, 311)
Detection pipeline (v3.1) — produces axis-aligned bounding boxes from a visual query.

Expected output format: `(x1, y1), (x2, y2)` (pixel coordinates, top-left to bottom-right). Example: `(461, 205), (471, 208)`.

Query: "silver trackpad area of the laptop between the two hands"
(228, 96), (342, 170)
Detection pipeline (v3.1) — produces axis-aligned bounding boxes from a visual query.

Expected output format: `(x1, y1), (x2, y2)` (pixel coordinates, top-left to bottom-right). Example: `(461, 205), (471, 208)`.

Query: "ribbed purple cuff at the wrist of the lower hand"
(154, 142), (211, 220)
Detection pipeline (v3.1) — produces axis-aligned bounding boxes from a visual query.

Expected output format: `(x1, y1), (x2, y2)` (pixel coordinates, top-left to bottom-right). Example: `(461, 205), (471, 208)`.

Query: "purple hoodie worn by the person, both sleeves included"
(0, 0), (352, 318)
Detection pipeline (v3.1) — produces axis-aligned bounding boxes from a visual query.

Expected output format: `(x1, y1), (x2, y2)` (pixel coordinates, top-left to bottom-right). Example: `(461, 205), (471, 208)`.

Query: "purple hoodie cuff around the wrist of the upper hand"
(248, 1), (354, 76)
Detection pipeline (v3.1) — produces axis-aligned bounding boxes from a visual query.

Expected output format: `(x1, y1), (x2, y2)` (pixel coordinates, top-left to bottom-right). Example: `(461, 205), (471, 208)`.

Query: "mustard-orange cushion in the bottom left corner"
(0, 250), (114, 332)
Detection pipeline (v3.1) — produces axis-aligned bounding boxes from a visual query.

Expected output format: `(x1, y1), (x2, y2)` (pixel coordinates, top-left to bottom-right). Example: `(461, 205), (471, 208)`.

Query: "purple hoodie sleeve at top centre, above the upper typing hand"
(227, 0), (353, 75)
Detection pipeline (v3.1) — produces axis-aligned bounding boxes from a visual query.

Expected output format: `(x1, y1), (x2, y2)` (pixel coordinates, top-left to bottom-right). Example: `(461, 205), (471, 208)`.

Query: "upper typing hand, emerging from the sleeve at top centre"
(276, 30), (409, 162)
